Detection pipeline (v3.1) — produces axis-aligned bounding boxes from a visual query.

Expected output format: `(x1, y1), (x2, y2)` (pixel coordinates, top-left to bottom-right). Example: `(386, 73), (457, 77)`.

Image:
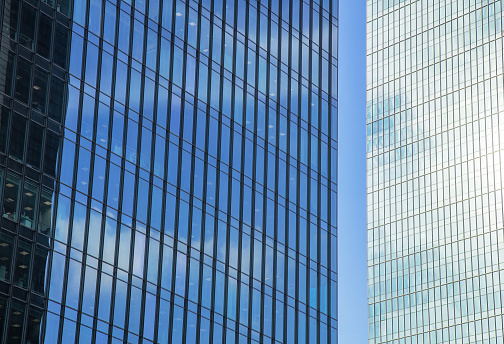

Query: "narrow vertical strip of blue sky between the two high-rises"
(338, 0), (368, 344)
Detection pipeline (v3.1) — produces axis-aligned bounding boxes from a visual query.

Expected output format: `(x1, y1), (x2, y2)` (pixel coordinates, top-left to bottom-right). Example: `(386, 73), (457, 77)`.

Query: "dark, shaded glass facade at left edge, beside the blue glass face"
(0, 0), (71, 344)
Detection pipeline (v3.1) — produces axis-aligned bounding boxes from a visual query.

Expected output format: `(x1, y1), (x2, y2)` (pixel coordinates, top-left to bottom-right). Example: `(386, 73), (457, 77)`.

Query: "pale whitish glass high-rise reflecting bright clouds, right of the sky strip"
(367, 0), (504, 344)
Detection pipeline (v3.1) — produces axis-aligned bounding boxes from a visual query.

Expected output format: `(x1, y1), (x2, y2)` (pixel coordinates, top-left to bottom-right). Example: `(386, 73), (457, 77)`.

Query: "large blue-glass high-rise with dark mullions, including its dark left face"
(0, 0), (338, 344)
